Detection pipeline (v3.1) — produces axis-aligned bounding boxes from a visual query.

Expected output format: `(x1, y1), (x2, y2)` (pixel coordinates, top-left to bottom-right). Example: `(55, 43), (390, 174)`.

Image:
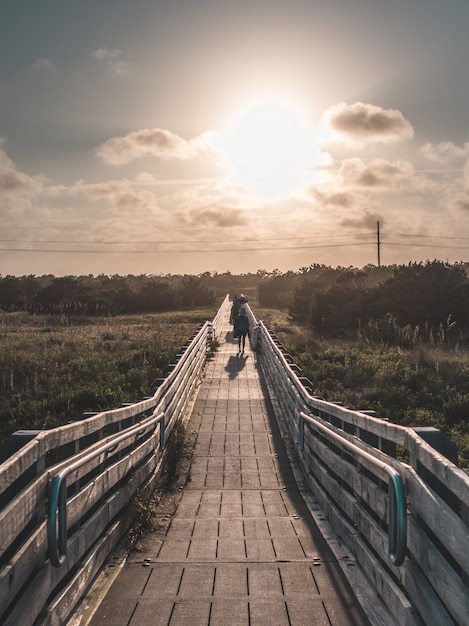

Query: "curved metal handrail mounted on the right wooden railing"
(298, 411), (407, 566)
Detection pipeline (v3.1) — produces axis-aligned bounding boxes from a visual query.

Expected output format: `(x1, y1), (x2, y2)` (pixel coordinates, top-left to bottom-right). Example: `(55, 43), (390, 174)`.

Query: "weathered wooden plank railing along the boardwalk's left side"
(0, 298), (229, 626)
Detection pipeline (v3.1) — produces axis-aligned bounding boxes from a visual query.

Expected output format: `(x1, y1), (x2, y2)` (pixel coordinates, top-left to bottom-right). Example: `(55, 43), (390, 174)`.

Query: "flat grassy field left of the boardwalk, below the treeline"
(0, 309), (216, 441)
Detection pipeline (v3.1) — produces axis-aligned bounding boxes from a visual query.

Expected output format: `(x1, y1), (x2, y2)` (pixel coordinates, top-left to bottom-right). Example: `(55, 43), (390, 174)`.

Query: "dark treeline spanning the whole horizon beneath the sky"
(0, 261), (469, 345)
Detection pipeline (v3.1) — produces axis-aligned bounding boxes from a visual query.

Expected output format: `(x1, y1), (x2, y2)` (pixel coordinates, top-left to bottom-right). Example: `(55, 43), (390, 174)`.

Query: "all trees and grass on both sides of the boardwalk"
(0, 261), (469, 467)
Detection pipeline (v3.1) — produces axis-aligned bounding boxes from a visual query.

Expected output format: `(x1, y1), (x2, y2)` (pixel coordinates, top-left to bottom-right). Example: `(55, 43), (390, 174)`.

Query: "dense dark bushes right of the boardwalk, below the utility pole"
(258, 261), (469, 346)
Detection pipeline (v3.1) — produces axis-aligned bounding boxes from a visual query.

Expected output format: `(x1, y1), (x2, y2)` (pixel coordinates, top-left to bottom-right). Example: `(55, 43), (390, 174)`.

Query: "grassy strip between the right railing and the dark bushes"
(255, 308), (469, 467)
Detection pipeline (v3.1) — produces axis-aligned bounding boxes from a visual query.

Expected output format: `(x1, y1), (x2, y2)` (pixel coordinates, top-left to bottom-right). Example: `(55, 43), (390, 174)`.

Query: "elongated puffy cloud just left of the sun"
(96, 128), (209, 165)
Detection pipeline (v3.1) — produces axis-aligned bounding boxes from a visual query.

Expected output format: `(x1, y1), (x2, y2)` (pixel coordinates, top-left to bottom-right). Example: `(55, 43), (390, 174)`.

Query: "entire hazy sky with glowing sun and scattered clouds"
(0, 0), (469, 276)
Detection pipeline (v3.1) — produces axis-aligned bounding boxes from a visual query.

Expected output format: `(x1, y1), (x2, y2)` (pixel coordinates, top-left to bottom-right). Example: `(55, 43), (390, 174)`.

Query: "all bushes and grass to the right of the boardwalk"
(257, 261), (469, 467)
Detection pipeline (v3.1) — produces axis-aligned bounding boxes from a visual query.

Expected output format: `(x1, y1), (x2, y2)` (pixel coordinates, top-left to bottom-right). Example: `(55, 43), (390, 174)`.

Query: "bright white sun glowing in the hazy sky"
(217, 101), (313, 200)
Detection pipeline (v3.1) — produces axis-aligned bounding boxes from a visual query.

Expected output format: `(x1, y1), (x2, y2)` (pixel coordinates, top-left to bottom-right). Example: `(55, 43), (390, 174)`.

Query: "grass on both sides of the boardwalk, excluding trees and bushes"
(0, 303), (469, 467)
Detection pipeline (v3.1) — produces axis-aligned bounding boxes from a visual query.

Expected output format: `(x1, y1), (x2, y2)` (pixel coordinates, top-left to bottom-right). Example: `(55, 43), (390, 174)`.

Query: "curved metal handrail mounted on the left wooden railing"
(47, 413), (165, 567)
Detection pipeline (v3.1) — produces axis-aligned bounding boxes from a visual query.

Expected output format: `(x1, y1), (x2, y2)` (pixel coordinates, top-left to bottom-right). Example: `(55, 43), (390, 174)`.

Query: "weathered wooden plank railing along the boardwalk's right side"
(250, 312), (469, 626)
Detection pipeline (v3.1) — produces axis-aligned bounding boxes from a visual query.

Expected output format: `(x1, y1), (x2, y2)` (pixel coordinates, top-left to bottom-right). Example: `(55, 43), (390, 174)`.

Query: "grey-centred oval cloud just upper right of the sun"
(320, 102), (414, 144)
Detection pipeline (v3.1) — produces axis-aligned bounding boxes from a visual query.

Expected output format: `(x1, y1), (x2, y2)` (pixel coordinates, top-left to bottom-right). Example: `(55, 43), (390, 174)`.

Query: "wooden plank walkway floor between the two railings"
(86, 314), (369, 626)
